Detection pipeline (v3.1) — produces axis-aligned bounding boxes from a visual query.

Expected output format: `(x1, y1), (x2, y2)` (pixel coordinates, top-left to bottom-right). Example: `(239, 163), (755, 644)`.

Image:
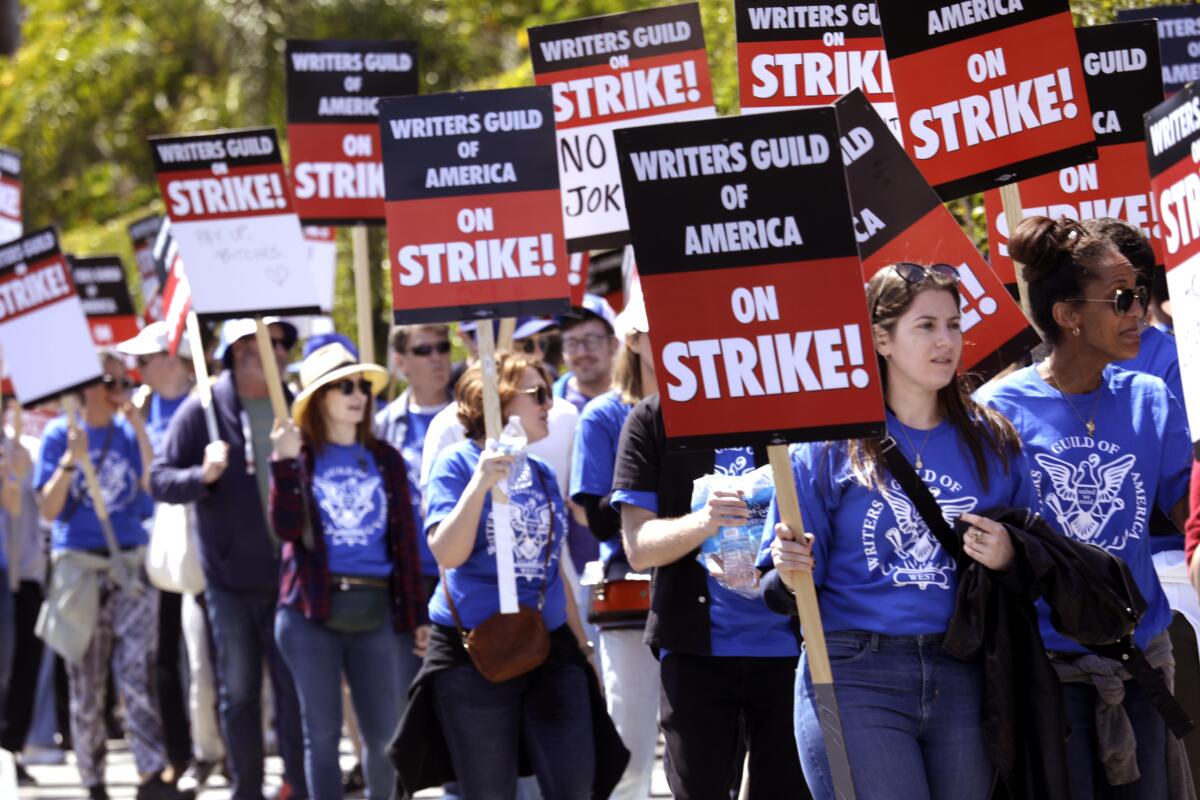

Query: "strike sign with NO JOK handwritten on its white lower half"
(529, 2), (716, 252)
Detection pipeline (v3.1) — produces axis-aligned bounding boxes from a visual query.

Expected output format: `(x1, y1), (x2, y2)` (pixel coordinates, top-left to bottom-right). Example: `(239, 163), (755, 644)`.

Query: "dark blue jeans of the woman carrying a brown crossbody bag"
(433, 656), (595, 800)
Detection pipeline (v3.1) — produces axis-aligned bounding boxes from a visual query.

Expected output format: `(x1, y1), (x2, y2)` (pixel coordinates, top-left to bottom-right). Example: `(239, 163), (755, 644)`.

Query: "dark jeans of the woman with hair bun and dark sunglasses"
(1062, 680), (1168, 800)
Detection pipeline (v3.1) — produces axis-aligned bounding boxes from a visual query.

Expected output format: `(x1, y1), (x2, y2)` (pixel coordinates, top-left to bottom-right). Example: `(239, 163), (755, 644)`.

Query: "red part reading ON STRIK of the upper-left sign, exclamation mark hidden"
(288, 122), (384, 222)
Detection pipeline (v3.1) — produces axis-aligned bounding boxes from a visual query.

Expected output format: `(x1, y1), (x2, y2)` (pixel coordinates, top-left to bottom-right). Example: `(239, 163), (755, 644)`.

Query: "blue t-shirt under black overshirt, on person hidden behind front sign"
(612, 447), (800, 657)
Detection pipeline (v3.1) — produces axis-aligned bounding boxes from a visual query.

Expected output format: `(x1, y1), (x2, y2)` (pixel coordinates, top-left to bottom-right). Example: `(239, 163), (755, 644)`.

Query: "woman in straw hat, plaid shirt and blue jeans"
(270, 342), (428, 800)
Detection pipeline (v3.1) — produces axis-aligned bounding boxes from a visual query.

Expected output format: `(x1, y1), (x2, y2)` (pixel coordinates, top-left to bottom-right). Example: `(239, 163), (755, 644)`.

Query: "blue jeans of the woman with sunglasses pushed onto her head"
(796, 631), (995, 800)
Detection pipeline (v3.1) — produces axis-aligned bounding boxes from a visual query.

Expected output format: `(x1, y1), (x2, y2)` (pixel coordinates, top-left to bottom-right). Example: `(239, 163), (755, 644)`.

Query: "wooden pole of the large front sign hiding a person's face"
(767, 445), (854, 800)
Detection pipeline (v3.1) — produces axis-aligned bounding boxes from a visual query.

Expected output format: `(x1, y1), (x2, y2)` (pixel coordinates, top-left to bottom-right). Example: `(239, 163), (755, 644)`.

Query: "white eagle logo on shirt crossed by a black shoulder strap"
(863, 479), (979, 591)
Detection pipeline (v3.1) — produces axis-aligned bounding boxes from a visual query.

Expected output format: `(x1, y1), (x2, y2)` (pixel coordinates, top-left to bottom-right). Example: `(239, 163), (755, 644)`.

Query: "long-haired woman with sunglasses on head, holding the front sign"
(760, 264), (1036, 800)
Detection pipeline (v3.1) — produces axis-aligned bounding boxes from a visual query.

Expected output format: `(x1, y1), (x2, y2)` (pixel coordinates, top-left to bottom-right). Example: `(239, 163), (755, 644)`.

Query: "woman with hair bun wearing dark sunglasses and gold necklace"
(978, 217), (1192, 800)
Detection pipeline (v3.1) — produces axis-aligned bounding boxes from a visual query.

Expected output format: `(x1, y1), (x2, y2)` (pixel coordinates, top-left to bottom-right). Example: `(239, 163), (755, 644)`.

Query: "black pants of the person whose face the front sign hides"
(659, 652), (811, 800)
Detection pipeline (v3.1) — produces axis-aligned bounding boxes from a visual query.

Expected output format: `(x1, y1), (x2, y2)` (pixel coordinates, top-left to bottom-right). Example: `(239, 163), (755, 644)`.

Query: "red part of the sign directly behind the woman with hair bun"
(984, 142), (1163, 283)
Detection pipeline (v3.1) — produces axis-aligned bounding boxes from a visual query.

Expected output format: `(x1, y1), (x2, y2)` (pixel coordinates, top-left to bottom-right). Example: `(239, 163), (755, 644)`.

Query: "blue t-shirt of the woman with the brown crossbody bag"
(425, 440), (566, 631)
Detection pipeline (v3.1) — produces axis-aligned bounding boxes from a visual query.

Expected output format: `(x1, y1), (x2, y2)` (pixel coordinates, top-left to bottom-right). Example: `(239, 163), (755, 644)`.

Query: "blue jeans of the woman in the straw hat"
(275, 608), (421, 800)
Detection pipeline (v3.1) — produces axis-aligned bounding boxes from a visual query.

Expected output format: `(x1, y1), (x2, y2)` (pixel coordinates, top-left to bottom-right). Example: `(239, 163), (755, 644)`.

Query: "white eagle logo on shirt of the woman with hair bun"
(1033, 437), (1146, 551)
